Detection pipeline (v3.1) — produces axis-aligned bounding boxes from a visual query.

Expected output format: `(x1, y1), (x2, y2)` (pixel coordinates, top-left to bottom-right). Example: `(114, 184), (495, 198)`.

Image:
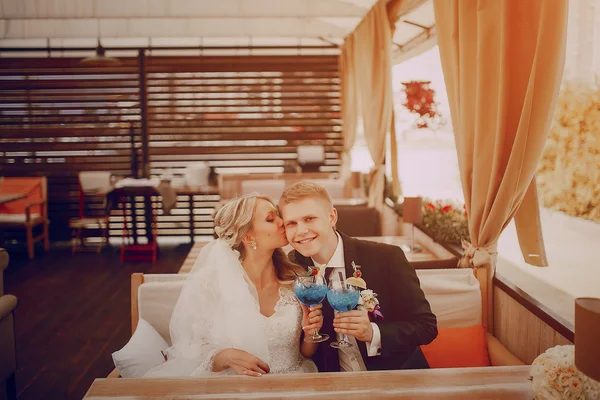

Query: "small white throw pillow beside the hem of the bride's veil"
(112, 318), (169, 378)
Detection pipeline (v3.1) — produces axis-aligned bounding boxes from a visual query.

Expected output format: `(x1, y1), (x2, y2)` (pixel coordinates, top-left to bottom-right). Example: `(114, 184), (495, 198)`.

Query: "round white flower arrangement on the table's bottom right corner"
(529, 345), (600, 400)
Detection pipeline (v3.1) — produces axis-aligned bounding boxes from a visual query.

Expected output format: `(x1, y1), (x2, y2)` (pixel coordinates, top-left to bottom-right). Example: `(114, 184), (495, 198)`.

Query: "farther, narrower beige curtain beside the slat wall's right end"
(342, 1), (396, 206)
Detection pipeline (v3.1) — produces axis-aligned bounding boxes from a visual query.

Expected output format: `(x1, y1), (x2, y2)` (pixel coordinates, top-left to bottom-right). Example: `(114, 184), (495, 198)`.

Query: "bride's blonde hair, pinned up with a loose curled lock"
(215, 193), (304, 284)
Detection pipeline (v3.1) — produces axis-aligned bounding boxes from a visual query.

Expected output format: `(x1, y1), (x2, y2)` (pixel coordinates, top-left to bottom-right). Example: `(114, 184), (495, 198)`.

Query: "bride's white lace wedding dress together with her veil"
(145, 239), (318, 377)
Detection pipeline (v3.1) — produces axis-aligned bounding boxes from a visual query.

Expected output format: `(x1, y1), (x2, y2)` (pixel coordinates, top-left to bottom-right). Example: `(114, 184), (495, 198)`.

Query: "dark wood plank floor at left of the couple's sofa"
(4, 244), (191, 400)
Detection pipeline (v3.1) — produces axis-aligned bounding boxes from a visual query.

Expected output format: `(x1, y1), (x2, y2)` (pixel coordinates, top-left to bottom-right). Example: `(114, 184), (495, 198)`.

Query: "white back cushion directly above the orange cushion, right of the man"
(417, 268), (481, 328)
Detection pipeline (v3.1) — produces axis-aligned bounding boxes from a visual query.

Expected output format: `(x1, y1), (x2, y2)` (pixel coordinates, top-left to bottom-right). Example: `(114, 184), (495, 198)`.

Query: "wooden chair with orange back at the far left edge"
(0, 177), (50, 260)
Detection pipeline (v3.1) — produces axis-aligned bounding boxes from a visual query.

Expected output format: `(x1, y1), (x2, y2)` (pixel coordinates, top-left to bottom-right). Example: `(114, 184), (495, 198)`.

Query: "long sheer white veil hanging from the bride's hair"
(146, 239), (269, 377)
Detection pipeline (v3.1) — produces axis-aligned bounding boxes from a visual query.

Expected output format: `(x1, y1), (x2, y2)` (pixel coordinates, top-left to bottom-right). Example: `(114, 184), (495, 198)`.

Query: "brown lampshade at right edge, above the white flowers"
(575, 297), (600, 381)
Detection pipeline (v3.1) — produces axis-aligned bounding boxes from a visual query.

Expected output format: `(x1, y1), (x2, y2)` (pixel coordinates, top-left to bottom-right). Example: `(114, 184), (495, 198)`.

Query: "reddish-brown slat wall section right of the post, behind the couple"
(146, 56), (343, 239)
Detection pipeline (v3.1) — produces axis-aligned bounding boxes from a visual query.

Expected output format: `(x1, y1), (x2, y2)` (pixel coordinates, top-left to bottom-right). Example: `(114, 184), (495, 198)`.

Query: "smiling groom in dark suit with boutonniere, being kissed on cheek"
(279, 181), (437, 372)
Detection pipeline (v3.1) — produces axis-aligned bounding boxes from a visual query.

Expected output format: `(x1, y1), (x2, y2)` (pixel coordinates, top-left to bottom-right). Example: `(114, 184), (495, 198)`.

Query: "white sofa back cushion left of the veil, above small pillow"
(138, 274), (185, 344)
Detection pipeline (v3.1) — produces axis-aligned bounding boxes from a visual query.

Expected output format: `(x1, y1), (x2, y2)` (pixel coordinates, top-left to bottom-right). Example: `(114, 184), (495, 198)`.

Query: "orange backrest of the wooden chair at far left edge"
(0, 176), (48, 215)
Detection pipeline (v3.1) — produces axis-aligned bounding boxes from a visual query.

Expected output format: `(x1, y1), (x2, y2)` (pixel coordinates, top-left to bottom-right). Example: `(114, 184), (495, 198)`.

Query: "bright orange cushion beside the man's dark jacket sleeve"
(421, 325), (491, 368)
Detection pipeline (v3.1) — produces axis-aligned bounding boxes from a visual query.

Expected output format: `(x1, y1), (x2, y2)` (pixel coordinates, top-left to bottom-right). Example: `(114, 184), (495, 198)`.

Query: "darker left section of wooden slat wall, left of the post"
(0, 58), (140, 239)
